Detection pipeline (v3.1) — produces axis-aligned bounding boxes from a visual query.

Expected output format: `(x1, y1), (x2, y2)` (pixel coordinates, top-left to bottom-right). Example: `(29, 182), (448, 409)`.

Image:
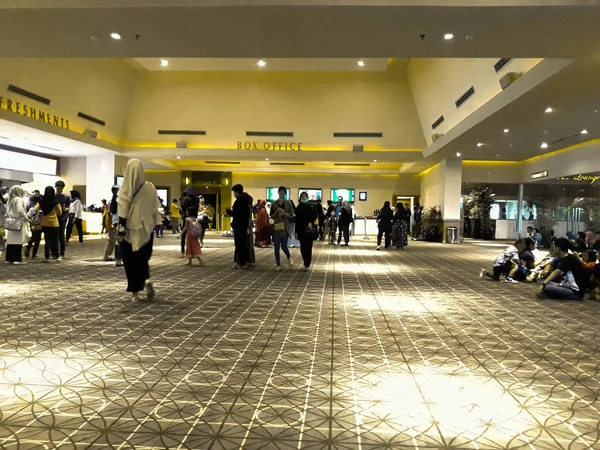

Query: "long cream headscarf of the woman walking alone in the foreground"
(117, 159), (161, 252)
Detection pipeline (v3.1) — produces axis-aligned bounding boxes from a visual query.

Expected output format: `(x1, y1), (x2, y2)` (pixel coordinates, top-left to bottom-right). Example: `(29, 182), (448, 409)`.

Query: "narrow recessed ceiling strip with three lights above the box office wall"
(133, 58), (389, 72)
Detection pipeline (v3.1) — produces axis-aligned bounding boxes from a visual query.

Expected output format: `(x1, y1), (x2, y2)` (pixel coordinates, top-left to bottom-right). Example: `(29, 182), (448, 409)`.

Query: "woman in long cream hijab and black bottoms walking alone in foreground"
(117, 159), (161, 301)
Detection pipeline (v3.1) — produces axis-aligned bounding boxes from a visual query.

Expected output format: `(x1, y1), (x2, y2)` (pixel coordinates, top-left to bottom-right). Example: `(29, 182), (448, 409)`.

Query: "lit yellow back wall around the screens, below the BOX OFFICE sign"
(233, 172), (420, 215)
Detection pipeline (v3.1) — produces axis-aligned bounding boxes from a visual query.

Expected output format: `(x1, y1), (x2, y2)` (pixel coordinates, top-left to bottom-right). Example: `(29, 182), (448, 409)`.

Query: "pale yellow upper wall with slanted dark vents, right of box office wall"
(407, 58), (541, 144)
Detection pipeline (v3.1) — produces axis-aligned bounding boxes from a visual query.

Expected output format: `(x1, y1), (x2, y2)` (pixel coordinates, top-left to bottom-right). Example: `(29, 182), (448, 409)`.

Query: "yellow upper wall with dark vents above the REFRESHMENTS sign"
(0, 58), (134, 143)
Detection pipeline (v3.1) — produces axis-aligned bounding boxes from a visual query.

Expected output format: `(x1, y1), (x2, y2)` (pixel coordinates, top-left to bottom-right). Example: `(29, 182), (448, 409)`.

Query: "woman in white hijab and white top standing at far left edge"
(5, 186), (28, 264)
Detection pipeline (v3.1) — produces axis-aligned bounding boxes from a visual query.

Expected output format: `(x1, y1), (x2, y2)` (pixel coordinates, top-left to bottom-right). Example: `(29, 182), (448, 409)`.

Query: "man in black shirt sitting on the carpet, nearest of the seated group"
(537, 238), (589, 300)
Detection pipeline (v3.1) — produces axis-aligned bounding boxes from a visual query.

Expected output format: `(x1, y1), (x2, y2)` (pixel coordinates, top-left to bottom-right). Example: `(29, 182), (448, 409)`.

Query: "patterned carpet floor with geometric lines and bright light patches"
(0, 236), (600, 450)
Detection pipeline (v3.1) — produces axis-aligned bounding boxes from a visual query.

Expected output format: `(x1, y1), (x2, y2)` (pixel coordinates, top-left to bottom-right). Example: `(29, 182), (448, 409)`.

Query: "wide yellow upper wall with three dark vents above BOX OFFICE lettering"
(127, 71), (425, 149)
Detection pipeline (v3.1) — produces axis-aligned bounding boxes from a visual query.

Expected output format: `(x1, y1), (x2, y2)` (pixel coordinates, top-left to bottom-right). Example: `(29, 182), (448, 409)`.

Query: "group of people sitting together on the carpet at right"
(480, 232), (600, 300)
